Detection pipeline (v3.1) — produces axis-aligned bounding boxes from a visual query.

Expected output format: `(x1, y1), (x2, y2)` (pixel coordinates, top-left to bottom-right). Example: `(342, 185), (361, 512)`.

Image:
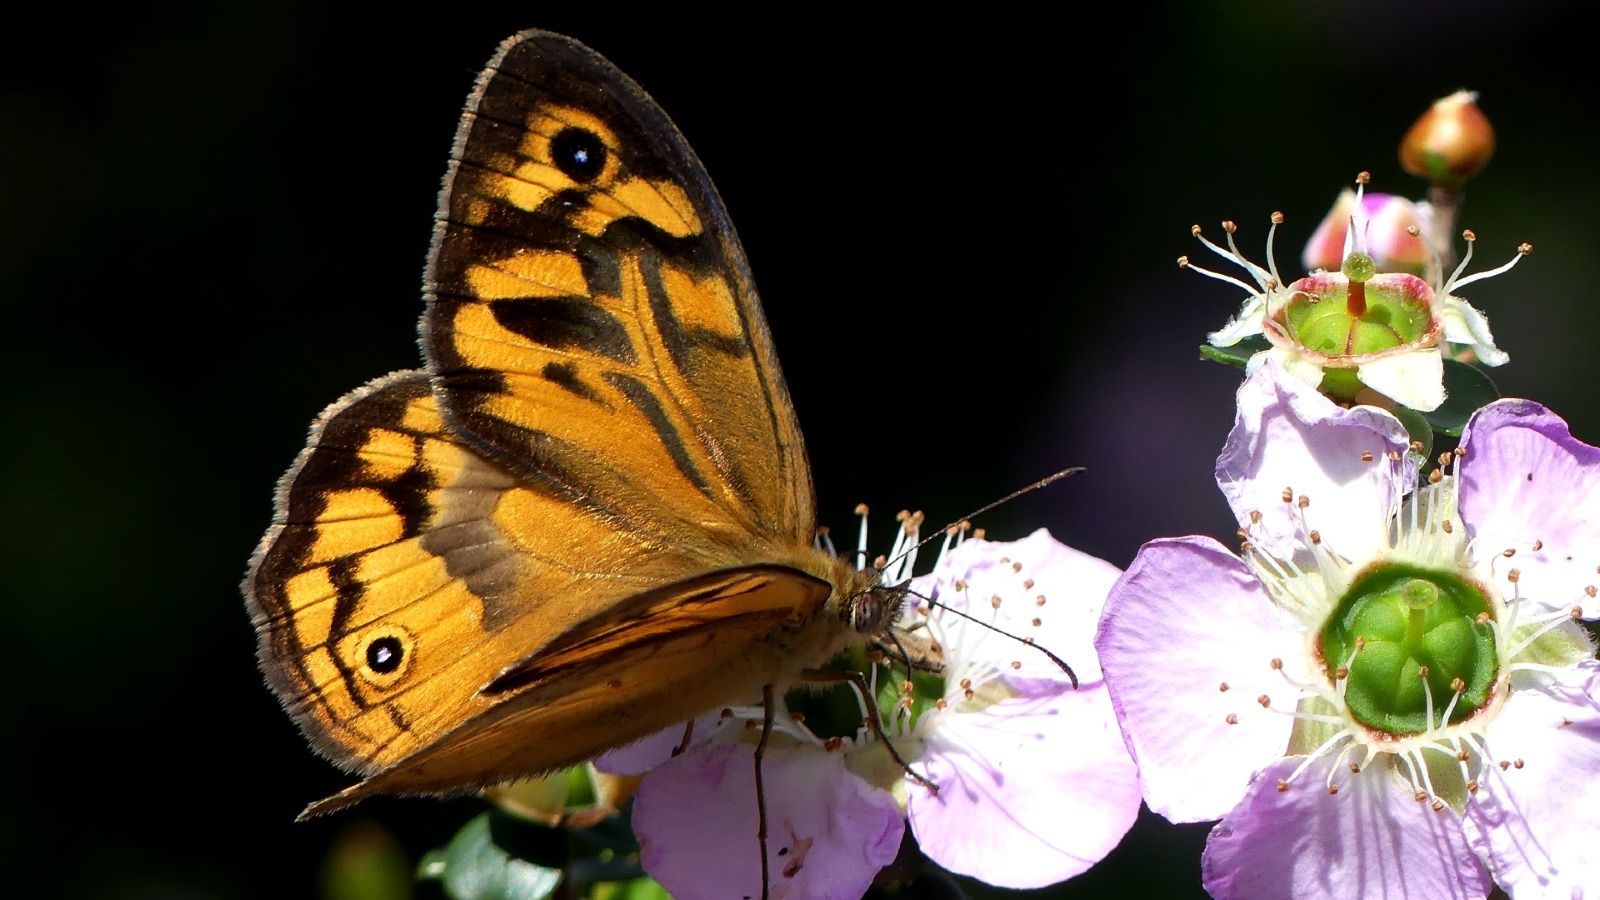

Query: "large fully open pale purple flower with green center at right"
(1096, 365), (1600, 900)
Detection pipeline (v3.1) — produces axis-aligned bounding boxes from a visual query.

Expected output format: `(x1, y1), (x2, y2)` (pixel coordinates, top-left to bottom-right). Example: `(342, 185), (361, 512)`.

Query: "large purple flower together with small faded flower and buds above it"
(1096, 85), (1600, 900)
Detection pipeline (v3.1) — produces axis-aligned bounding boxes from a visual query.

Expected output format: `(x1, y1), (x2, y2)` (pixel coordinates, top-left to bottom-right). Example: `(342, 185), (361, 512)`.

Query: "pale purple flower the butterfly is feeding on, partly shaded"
(603, 530), (1139, 898)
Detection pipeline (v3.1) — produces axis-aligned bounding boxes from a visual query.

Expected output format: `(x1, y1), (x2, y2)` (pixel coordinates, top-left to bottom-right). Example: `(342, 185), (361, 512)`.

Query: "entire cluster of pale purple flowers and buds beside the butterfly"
(448, 93), (1600, 900)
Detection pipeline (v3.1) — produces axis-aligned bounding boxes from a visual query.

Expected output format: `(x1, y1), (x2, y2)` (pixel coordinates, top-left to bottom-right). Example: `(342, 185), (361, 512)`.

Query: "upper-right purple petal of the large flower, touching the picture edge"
(1461, 400), (1600, 618)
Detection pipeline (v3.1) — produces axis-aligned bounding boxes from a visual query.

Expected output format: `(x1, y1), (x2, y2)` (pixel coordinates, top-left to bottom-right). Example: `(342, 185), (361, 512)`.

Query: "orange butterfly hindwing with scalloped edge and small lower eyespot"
(246, 373), (780, 772)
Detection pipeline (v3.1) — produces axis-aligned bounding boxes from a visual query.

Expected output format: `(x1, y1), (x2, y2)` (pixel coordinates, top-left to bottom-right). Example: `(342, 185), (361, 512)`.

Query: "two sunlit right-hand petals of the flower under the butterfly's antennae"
(894, 528), (1139, 887)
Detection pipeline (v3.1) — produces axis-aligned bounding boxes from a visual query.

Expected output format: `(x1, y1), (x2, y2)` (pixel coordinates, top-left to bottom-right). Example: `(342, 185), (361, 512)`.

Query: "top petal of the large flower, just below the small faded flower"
(1216, 362), (1416, 560)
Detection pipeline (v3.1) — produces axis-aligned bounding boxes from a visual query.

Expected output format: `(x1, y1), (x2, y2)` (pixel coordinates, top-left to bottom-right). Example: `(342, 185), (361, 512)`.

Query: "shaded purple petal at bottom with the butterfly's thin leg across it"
(634, 743), (906, 900)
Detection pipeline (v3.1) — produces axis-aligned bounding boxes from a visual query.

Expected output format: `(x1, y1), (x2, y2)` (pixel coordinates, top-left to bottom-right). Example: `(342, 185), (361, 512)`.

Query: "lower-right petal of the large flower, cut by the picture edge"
(1464, 661), (1600, 898)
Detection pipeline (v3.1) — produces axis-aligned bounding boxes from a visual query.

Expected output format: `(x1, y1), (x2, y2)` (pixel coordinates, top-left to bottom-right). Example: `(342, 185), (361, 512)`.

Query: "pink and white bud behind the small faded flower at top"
(1302, 189), (1430, 275)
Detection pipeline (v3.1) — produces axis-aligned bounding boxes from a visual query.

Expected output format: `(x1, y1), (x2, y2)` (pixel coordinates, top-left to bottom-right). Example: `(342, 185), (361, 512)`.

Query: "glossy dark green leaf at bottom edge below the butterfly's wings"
(418, 812), (562, 900)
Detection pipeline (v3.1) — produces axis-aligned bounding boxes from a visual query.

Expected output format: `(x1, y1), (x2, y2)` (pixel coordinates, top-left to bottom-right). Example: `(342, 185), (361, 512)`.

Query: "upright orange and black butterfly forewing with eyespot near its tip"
(424, 32), (814, 544)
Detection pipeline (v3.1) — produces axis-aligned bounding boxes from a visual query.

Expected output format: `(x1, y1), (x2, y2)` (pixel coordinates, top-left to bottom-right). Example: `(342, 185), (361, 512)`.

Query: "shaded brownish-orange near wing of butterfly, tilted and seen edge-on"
(304, 565), (830, 815)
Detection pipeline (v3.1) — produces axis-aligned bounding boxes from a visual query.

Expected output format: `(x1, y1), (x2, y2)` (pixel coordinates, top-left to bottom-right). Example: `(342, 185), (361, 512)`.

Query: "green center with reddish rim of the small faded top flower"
(1278, 267), (1434, 357)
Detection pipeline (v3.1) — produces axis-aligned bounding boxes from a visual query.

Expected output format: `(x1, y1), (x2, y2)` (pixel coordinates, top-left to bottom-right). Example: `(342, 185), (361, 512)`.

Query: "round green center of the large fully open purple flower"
(1322, 564), (1499, 737)
